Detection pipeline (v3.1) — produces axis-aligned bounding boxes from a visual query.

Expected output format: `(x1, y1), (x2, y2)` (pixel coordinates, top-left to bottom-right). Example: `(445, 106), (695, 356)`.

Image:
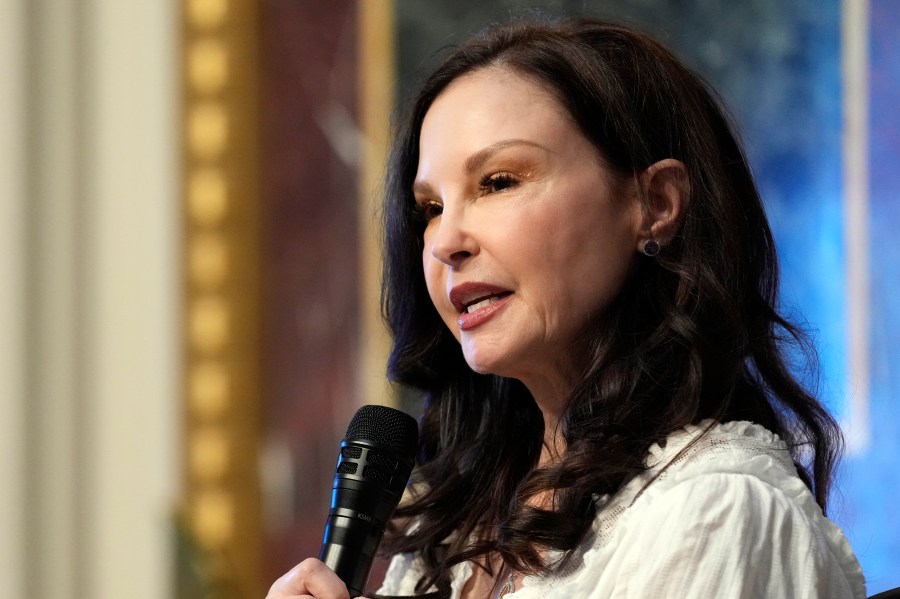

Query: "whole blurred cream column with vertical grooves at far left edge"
(0, 0), (181, 599)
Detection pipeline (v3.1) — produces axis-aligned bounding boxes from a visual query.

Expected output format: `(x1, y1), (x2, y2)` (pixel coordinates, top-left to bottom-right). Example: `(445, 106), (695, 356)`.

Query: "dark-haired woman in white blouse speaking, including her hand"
(270, 20), (865, 599)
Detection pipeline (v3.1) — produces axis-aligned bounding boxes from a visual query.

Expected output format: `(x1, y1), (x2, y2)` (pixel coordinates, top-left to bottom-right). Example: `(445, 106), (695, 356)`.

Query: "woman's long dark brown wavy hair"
(382, 19), (841, 594)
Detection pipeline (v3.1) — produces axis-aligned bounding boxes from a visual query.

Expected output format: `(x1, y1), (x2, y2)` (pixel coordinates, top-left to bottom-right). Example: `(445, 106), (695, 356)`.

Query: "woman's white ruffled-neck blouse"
(378, 421), (866, 599)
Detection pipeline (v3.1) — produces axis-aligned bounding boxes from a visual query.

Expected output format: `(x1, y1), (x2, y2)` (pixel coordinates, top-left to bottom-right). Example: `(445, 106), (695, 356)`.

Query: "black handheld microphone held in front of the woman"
(319, 405), (419, 597)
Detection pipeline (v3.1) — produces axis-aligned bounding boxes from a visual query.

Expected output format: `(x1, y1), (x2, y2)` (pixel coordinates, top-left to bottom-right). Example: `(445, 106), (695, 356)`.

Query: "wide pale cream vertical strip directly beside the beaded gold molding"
(83, 0), (181, 599)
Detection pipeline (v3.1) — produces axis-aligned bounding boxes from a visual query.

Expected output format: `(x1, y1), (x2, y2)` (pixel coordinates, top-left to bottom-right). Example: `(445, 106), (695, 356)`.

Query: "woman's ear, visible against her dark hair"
(638, 158), (691, 251)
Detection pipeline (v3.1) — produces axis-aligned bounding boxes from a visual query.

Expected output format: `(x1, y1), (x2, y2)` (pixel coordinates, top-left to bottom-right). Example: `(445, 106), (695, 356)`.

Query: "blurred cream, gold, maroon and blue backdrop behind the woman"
(0, 0), (900, 599)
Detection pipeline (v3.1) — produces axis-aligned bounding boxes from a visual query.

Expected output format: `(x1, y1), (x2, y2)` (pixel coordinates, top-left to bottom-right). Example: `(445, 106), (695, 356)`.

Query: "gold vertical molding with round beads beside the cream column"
(182, 0), (265, 597)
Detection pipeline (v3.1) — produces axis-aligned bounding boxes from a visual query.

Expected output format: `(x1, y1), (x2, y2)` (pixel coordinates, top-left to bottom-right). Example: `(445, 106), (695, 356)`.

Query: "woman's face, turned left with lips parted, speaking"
(414, 67), (646, 397)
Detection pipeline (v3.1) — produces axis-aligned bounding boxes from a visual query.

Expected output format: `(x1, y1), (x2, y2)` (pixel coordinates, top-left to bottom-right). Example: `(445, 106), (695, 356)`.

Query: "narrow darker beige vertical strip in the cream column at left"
(21, 0), (84, 598)
